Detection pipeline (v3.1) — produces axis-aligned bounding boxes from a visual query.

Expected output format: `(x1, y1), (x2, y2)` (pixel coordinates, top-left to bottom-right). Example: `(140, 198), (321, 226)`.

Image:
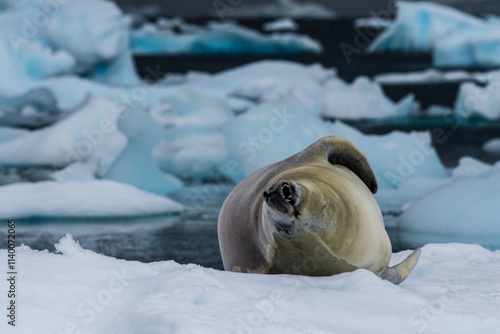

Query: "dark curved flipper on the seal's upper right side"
(316, 137), (378, 194)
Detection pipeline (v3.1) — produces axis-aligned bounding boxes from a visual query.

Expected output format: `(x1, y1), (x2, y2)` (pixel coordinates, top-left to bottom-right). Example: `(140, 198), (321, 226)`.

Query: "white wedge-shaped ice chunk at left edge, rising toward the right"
(0, 98), (126, 175)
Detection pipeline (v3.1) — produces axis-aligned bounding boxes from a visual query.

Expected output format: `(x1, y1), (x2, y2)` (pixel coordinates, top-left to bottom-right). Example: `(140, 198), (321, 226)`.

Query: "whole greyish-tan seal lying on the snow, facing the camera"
(218, 137), (419, 283)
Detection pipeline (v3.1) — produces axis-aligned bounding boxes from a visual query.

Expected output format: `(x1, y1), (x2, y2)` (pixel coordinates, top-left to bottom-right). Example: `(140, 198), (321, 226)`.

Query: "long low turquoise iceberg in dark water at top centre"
(131, 22), (322, 55)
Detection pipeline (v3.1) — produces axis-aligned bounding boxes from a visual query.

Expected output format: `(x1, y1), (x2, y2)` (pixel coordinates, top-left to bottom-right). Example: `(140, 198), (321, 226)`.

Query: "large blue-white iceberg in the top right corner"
(368, 2), (500, 67)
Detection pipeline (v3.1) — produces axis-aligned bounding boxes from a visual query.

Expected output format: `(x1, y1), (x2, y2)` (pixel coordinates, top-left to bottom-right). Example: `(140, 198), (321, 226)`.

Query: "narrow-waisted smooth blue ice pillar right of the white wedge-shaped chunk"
(104, 109), (182, 195)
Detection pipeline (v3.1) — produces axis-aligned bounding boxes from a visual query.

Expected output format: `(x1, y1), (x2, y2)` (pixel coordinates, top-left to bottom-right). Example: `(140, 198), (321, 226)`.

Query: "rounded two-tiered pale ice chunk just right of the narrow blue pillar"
(154, 89), (233, 181)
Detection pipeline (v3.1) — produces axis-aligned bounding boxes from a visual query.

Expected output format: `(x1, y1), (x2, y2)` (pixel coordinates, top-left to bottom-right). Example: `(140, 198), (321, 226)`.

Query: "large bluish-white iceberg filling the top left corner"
(0, 0), (140, 90)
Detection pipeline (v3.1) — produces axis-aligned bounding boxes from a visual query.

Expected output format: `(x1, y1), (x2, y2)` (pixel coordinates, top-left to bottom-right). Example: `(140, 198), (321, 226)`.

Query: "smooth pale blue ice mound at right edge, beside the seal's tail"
(398, 164), (500, 246)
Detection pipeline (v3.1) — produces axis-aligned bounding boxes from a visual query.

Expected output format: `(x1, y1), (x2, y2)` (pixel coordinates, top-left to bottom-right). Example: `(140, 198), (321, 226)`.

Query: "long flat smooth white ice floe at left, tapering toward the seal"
(0, 181), (182, 219)
